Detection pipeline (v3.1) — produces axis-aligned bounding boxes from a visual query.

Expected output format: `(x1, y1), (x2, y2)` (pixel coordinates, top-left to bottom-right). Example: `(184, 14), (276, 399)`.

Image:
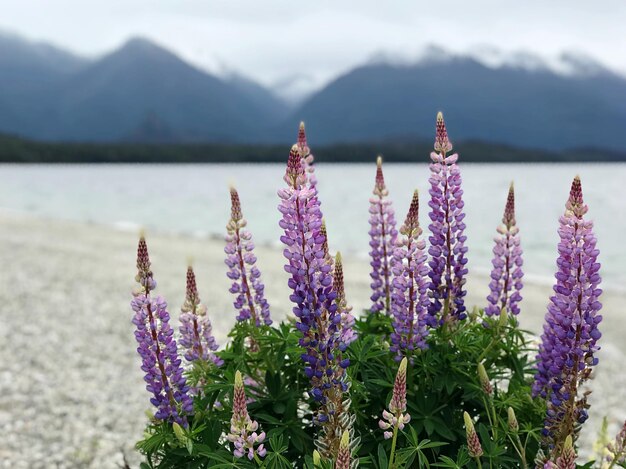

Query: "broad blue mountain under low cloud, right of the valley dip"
(289, 57), (626, 150)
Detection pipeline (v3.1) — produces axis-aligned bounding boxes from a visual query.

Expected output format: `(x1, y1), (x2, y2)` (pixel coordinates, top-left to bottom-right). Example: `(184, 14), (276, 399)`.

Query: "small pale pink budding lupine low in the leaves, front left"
(226, 370), (267, 460)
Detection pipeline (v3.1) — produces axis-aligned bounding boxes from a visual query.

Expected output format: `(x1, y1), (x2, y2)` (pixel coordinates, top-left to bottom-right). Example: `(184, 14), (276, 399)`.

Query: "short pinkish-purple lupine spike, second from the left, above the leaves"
(180, 266), (224, 366)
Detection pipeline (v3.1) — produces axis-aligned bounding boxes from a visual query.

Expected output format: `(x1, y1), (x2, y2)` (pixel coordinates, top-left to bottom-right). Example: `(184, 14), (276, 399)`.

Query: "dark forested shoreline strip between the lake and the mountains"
(0, 135), (626, 164)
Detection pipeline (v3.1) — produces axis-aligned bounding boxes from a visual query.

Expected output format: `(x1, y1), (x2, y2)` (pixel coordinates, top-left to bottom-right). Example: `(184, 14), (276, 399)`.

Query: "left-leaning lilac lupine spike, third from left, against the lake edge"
(224, 187), (272, 326)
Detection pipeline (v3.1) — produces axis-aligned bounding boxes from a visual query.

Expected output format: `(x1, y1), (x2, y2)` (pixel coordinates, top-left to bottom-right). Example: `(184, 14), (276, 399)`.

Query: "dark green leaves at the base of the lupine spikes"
(137, 312), (545, 469)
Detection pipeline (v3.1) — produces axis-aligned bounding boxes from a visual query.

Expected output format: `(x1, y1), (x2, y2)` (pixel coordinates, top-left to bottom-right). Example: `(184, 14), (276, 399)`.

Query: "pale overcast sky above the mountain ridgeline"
(0, 0), (626, 91)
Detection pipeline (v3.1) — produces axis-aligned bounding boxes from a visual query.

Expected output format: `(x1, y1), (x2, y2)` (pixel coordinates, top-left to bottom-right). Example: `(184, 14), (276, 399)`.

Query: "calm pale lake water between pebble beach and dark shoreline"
(0, 164), (626, 289)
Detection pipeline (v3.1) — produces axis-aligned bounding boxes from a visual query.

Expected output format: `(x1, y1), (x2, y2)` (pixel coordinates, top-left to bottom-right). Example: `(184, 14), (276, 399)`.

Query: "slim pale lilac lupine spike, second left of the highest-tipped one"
(369, 156), (398, 314)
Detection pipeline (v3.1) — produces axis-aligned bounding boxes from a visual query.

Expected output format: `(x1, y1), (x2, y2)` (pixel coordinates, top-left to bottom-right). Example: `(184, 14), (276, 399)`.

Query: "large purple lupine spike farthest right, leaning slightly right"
(533, 176), (602, 448)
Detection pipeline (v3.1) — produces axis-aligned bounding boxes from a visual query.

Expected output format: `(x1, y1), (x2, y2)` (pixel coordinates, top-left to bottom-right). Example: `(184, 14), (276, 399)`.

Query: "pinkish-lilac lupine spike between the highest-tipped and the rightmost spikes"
(485, 183), (524, 316)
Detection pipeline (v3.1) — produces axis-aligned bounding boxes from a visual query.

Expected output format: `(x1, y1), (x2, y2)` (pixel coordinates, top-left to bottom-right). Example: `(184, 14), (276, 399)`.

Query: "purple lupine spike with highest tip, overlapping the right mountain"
(428, 113), (467, 327)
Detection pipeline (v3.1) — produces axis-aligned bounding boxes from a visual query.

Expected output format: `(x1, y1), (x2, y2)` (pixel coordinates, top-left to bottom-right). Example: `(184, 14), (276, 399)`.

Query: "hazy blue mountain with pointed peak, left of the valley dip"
(0, 35), (285, 142)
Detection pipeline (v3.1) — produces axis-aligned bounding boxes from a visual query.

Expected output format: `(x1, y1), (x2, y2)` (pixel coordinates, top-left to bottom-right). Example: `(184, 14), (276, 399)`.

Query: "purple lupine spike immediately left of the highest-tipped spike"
(390, 190), (429, 360)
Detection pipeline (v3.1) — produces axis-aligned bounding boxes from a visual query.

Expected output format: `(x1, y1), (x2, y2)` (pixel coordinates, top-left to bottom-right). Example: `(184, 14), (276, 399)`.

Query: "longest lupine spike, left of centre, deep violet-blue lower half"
(278, 145), (350, 457)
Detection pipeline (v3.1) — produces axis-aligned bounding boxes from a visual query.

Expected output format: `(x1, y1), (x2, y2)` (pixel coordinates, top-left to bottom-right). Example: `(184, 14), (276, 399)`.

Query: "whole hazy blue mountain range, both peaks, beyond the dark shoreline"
(0, 31), (626, 150)
